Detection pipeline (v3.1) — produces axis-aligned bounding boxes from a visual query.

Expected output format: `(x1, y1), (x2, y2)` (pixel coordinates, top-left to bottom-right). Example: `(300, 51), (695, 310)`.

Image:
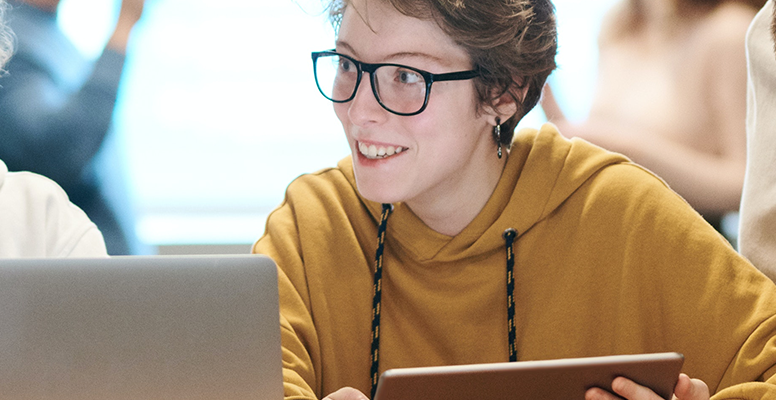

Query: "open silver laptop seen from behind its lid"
(0, 255), (283, 400)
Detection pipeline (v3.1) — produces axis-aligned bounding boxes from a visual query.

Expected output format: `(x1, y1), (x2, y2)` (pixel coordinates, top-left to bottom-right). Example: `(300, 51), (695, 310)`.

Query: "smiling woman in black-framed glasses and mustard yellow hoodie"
(253, 0), (776, 400)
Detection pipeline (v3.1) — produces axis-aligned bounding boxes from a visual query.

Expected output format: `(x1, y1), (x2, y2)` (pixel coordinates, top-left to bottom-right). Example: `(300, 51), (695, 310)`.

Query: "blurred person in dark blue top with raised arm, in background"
(0, 0), (144, 255)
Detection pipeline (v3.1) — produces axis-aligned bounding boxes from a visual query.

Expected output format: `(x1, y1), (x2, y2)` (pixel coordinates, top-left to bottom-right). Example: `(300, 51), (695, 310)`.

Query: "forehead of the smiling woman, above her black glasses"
(337, 0), (469, 64)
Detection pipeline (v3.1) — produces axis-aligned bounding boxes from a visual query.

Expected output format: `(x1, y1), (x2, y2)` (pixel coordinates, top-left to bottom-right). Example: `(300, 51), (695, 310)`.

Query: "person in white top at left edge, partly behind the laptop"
(0, 0), (107, 258)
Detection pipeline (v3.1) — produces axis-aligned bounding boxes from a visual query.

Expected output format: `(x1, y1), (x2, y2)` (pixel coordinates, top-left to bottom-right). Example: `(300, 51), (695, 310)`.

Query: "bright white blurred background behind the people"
(58, 0), (615, 254)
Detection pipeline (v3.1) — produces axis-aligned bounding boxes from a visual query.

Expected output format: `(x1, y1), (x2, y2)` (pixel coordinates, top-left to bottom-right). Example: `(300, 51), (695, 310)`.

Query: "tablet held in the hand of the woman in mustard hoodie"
(374, 353), (684, 400)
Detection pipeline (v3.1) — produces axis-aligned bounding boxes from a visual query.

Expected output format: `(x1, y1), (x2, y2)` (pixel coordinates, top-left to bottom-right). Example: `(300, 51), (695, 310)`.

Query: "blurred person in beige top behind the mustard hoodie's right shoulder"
(542, 0), (765, 234)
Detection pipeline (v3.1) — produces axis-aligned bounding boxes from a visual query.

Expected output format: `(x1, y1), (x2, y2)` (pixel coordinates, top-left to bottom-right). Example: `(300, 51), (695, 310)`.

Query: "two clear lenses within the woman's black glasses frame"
(315, 54), (426, 114)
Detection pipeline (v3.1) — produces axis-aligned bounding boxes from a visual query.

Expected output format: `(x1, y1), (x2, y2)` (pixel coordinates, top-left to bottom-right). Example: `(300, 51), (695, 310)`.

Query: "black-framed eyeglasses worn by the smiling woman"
(312, 50), (479, 116)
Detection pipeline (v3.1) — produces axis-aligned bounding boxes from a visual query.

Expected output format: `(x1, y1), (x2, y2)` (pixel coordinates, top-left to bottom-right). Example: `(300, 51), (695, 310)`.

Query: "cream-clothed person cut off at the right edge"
(738, 0), (776, 280)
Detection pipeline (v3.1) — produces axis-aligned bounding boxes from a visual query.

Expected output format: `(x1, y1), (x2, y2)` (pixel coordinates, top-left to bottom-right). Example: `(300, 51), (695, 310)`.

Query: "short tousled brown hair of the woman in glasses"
(330, 0), (558, 146)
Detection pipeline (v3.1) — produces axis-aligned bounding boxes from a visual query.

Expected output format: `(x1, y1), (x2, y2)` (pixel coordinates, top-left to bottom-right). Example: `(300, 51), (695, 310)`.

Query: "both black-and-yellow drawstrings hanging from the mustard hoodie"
(369, 204), (517, 399)
